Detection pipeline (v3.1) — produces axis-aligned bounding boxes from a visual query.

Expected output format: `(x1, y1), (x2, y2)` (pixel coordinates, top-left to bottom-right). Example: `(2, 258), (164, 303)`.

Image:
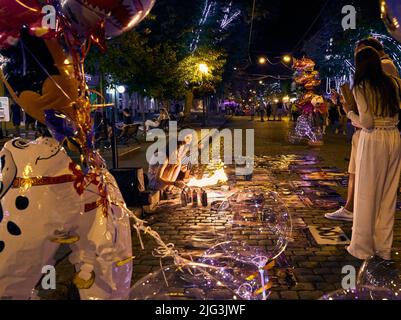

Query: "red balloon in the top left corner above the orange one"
(0, 0), (54, 49)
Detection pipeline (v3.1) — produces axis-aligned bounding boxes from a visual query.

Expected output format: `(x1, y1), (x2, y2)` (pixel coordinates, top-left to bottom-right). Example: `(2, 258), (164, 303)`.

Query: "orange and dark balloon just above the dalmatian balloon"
(0, 29), (79, 123)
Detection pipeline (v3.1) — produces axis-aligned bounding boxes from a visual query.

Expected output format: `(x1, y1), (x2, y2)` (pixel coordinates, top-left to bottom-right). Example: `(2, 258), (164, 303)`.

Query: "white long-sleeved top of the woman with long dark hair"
(347, 79), (401, 130)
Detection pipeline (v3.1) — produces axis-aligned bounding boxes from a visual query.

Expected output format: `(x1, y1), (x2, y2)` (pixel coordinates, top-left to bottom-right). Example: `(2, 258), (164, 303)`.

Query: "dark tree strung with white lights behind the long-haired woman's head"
(303, 1), (401, 94)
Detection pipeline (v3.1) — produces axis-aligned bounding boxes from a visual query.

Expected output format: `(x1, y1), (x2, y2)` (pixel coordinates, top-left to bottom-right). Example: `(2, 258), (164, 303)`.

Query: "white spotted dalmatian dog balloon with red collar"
(0, 137), (132, 299)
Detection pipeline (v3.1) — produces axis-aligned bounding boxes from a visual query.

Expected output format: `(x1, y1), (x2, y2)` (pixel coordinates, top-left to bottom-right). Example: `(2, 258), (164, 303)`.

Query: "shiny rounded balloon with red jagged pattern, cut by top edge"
(62, 0), (156, 43)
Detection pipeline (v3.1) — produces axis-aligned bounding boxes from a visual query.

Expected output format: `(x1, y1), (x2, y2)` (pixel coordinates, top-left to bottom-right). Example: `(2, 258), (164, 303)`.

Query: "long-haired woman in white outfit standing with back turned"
(344, 47), (401, 260)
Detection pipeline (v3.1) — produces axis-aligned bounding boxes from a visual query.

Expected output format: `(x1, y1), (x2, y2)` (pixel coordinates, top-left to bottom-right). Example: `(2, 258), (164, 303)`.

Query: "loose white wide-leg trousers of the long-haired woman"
(347, 128), (401, 260)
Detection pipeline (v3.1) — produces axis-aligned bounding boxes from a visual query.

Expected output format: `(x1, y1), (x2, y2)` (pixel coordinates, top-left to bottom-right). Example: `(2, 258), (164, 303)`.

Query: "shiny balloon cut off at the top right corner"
(381, 0), (401, 42)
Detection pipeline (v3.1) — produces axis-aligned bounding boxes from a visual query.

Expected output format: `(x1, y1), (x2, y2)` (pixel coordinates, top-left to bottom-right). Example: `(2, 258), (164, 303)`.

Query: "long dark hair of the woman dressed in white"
(354, 47), (399, 117)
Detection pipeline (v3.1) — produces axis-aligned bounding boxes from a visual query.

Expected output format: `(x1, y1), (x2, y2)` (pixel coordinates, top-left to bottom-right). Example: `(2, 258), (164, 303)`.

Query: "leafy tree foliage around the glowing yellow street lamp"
(86, 0), (265, 99)
